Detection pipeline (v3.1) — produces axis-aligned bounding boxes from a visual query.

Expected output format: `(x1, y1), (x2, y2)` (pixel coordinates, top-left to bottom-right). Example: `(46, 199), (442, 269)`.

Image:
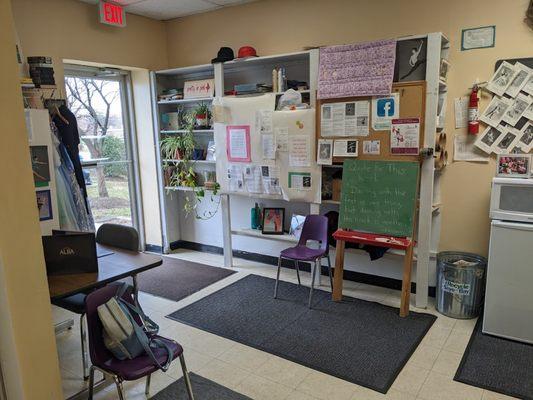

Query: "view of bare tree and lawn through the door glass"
(65, 76), (132, 225)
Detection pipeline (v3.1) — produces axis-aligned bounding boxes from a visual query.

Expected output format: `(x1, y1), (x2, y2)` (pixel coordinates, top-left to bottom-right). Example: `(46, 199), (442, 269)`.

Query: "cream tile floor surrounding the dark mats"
(54, 251), (510, 400)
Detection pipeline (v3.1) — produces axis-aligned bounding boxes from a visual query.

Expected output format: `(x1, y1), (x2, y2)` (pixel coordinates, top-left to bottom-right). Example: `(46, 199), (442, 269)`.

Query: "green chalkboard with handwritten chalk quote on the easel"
(339, 160), (419, 237)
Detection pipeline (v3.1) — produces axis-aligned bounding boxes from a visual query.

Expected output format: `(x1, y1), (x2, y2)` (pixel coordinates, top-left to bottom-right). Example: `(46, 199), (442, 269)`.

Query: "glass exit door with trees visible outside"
(65, 65), (141, 232)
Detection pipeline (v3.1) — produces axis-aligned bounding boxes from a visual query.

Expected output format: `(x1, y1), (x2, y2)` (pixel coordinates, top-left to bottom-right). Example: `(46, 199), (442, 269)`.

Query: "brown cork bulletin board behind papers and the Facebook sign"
(316, 81), (426, 164)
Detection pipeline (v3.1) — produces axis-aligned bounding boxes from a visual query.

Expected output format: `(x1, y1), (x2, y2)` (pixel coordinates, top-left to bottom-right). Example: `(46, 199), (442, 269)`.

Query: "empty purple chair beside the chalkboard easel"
(274, 215), (333, 308)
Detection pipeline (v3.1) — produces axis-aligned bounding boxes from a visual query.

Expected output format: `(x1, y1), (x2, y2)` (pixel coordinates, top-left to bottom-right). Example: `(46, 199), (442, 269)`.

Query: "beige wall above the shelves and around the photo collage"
(167, 0), (533, 254)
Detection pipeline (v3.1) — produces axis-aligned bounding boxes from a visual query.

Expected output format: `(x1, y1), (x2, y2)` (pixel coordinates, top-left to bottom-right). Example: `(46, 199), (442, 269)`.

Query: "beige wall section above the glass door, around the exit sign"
(12, 0), (167, 86)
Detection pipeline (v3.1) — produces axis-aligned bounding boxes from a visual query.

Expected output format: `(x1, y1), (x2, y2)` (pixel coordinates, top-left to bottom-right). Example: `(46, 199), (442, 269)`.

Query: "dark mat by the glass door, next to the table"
(138, 257), (235, 301)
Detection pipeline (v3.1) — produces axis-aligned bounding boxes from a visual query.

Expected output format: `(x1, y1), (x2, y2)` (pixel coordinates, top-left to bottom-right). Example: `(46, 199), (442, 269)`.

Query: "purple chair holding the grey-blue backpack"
(85, 285), (194, 400)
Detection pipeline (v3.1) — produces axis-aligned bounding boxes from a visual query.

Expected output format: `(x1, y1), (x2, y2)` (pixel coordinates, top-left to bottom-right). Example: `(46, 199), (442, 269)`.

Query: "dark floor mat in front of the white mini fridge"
(454, 317), (533, 400)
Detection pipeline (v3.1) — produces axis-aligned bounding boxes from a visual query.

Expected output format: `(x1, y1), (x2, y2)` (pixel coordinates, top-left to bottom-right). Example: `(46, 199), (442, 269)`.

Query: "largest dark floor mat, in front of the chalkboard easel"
(168, 275), (436, 393)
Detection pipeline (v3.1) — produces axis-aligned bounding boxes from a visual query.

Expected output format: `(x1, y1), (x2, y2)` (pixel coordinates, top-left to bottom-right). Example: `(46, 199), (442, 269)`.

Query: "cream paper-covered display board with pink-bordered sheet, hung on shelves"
(214, 93), (322, 203)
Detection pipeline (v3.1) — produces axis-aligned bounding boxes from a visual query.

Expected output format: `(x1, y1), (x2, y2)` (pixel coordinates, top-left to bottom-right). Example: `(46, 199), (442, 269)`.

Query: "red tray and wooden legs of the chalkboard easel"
(332, 229), (414, 317)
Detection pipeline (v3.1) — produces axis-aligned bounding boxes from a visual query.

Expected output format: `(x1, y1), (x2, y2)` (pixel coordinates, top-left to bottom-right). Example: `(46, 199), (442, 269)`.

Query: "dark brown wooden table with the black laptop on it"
(48, 245), (163, 300)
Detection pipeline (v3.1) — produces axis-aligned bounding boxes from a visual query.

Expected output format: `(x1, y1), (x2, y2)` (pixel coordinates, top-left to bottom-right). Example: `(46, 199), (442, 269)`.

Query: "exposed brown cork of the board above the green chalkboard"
(315, 81), (426, 164)
